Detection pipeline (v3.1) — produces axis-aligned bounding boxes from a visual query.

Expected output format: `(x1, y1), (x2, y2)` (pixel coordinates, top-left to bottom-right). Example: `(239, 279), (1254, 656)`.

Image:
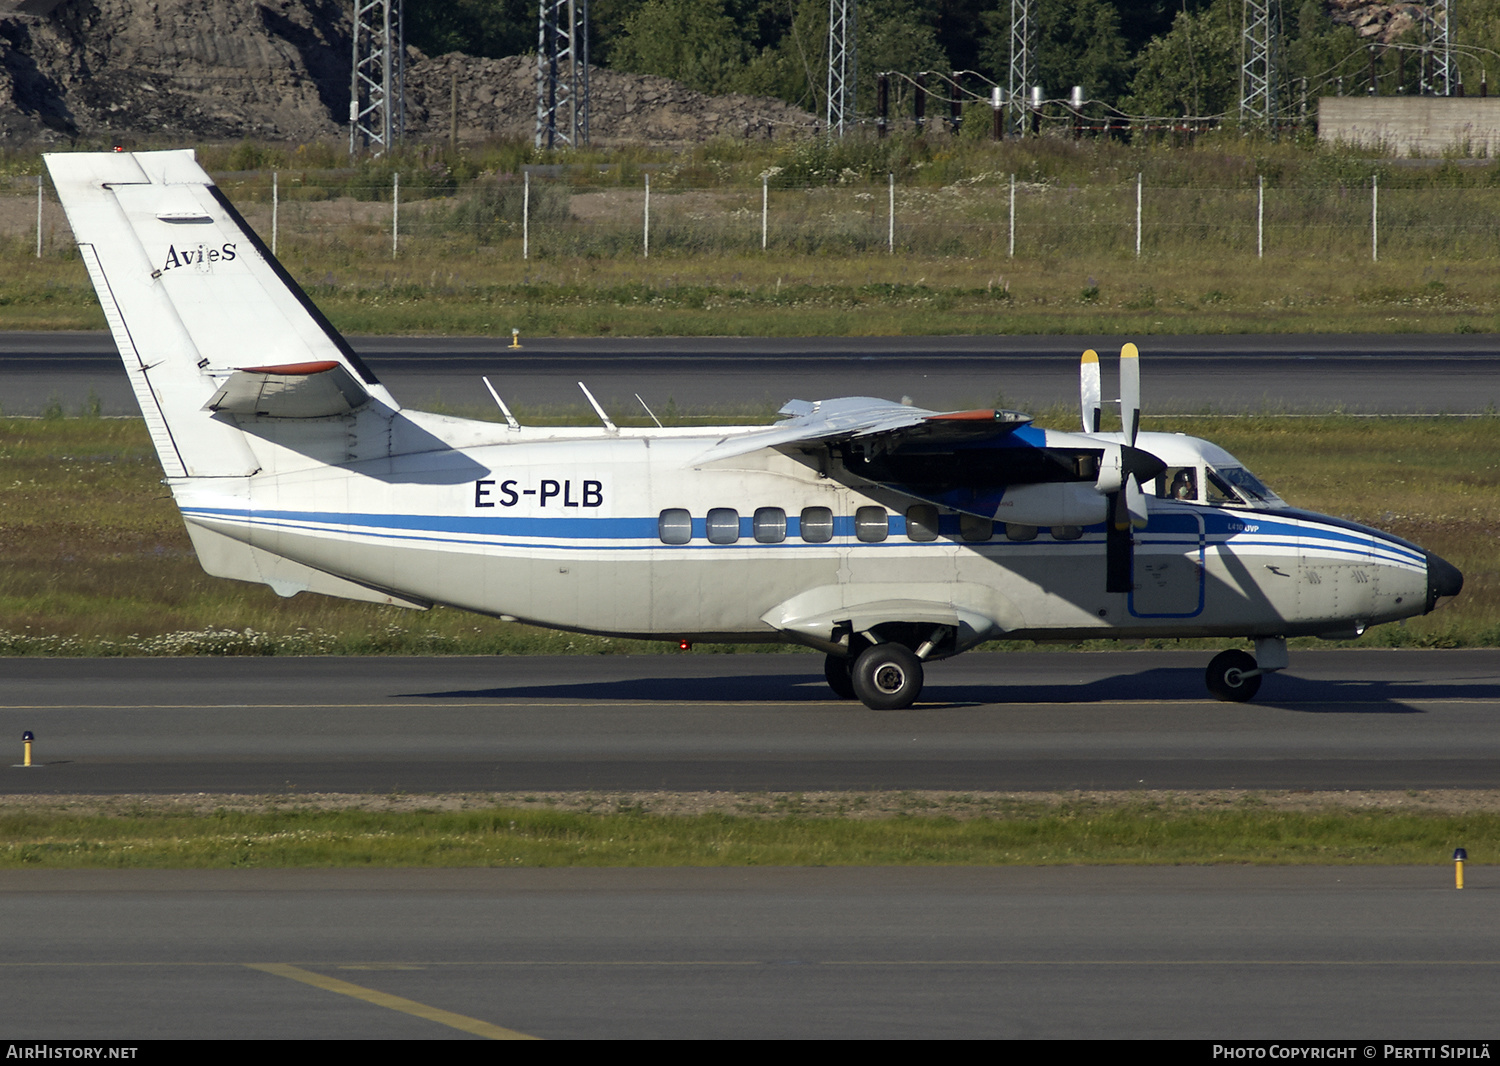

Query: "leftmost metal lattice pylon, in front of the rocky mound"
(350, 0), (407, 156)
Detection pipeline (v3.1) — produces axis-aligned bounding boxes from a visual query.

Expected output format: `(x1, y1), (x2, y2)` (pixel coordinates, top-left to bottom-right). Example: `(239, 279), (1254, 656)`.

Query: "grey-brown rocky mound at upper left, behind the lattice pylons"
(0, 0), (816, 145)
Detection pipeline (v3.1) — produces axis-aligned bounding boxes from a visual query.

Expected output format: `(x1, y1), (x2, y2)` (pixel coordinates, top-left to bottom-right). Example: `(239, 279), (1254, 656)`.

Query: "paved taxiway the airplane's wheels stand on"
(0, 649), (1500, 793)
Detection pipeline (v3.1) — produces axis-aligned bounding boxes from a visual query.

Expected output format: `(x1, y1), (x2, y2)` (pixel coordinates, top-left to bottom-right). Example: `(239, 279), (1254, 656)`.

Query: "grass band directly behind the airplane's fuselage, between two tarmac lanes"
(0, 412), (1500, 655)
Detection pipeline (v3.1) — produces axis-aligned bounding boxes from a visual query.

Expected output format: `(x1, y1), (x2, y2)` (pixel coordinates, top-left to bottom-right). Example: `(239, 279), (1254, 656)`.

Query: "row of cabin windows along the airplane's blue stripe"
(657, 504), (1083, 544)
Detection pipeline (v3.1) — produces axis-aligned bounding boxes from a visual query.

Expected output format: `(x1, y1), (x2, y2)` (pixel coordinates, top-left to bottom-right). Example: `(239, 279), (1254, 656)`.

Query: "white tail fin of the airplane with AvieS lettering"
(45, 150), (398, 477)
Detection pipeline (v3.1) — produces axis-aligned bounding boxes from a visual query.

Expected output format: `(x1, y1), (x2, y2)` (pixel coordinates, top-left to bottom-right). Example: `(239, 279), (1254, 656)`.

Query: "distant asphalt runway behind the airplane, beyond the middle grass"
(0, 333), (1500, 413)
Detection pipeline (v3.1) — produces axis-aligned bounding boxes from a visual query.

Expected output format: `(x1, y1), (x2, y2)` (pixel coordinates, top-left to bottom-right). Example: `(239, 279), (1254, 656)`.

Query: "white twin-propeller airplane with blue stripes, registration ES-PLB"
(47, 150), (1463, 711)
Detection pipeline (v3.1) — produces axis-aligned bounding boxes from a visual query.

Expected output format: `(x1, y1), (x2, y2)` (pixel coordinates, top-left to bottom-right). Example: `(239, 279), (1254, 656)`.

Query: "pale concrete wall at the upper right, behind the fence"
(1317, 96), (1500, 156)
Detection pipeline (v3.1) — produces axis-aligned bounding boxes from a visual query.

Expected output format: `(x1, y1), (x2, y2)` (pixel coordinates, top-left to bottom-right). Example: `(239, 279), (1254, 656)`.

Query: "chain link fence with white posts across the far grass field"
(0, 168), (1500, 261)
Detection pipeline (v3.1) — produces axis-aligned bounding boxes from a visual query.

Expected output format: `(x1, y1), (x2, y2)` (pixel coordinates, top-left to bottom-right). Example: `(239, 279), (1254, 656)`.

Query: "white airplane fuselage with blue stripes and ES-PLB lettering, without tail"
(174, 415), (1428, 646)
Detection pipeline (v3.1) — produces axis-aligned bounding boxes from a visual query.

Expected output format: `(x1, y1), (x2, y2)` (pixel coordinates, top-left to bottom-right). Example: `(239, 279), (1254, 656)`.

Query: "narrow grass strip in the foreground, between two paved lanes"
(0, 793), (1500, 870)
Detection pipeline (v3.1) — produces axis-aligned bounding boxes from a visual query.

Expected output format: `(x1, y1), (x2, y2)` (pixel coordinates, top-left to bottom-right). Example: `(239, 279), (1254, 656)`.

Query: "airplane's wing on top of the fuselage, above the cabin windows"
(692, 396), (1031, 466)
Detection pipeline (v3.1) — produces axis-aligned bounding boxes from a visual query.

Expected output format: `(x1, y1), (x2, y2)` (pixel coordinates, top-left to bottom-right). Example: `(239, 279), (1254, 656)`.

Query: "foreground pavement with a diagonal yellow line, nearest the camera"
(0, 864), (1500, 1059)
